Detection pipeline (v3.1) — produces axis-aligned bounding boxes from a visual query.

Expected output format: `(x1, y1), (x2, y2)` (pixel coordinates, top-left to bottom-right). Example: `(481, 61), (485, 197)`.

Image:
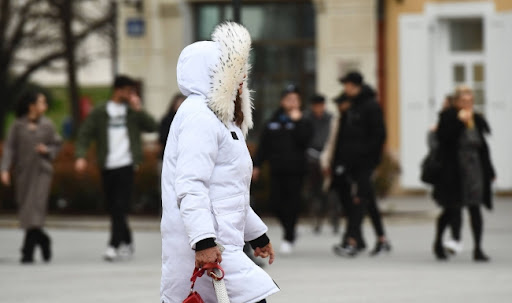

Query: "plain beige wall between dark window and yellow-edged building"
(314, 0), (377, 111)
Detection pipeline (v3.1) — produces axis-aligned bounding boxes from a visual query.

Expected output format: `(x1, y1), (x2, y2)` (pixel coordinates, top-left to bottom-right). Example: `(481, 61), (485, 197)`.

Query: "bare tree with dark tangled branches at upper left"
(0, 0), (114, 136)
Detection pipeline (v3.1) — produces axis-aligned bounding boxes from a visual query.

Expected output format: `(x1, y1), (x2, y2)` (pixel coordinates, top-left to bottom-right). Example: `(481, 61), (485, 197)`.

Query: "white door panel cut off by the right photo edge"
(485, 13), (512, 190)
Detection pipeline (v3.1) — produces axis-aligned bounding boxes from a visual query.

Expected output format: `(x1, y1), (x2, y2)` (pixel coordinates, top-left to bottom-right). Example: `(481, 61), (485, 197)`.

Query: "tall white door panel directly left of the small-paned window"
(399, 15), (431, 189)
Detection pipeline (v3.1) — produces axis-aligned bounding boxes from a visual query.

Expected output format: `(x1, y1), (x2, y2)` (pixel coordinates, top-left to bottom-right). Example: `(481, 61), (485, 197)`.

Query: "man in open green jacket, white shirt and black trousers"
(75, 75), (157, 261)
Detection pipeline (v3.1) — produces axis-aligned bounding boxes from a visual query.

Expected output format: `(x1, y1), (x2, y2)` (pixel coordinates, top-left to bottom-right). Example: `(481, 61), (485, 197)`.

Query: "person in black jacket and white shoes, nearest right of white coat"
(253, 85), (312, 254)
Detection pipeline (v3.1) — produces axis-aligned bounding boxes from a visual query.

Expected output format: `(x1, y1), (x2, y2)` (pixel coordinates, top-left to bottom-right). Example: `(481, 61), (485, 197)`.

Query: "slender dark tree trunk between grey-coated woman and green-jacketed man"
(61, 0), (80, 137)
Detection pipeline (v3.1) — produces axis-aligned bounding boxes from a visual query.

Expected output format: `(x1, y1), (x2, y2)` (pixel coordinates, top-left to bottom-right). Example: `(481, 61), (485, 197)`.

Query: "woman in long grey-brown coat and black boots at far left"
(1, 92), (61, 264)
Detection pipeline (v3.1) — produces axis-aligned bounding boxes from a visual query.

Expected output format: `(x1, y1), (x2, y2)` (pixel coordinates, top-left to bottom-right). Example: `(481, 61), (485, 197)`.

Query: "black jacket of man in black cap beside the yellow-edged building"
(333, 85), (386, 170)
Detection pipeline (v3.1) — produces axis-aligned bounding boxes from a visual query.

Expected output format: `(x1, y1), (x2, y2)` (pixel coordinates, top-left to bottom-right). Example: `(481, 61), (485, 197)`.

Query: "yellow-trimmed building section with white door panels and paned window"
(385, 0), (512, 190)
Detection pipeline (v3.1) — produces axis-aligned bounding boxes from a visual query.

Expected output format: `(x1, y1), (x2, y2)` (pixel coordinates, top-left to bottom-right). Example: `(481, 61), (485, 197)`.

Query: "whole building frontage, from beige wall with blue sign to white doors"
(118, 0), (512, 190)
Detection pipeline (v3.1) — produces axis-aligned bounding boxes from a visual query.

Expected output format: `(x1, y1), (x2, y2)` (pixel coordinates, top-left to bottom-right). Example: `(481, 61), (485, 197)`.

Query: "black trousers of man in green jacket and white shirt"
(102, 165), (135, 248)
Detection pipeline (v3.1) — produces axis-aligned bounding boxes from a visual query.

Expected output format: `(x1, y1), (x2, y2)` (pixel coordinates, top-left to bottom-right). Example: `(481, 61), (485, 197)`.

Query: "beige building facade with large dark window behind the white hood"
(118, 0), (377, 141)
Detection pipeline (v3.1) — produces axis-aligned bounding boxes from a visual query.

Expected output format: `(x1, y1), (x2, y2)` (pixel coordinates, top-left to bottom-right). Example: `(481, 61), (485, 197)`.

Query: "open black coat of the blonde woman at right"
(433, 108), (496, 209)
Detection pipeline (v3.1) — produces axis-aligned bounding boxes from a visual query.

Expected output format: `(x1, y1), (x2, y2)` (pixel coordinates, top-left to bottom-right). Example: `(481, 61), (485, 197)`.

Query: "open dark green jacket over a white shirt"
(75, 104), (158, 169)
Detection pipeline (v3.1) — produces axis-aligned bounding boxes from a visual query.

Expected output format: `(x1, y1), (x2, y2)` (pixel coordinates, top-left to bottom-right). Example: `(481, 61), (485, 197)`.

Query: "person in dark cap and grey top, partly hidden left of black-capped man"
(304, 95), (336, 233)
